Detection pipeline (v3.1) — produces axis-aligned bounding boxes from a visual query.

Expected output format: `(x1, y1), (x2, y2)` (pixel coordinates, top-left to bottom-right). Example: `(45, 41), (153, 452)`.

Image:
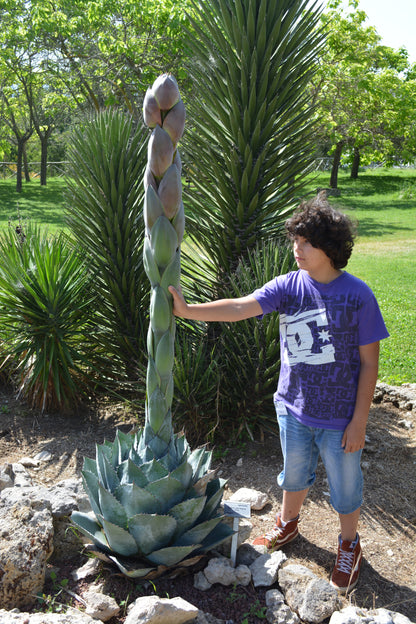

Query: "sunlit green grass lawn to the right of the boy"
(304, 169), (416, 384)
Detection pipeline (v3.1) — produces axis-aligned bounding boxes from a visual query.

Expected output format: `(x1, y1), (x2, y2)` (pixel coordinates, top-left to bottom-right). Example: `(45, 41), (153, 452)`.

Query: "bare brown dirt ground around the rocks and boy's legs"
(0, 387), (416, 624)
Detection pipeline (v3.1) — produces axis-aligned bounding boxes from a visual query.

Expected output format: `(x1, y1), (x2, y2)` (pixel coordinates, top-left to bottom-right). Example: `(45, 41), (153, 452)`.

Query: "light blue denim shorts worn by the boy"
(277, 412), (363, 514)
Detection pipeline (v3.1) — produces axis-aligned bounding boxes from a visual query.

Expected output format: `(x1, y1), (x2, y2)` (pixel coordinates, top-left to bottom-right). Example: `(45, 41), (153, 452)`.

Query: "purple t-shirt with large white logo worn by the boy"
(253, 270), (389, 430)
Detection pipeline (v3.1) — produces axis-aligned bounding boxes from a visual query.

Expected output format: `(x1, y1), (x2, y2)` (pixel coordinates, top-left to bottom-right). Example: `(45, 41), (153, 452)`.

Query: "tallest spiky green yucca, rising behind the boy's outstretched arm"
(186, 0), (323, 286)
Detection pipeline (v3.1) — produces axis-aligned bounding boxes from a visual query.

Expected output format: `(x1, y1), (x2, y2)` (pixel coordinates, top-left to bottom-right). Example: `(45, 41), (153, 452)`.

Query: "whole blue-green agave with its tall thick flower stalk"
(72, 74), (232, 578)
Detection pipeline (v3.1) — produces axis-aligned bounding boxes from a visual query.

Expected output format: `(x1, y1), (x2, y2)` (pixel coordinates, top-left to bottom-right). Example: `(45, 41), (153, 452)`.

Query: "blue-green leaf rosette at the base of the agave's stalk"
(71, 432), (231, 577)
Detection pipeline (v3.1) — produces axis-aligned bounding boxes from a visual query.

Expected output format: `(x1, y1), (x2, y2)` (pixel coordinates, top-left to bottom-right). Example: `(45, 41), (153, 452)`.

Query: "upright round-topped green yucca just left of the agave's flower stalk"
(67, 109), (148, 386)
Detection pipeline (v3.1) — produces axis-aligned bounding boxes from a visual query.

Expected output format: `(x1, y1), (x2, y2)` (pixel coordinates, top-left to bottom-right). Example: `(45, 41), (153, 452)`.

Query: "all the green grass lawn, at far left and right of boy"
(0, 169), (416, 384)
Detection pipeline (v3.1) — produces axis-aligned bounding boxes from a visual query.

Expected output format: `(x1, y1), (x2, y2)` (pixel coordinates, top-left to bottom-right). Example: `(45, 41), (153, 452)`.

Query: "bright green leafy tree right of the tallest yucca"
(311, 0), (416, 188)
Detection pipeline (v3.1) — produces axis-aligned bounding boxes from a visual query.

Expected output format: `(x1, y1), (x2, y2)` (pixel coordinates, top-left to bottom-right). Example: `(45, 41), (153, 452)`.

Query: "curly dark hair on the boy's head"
(285, 193), (355, 269)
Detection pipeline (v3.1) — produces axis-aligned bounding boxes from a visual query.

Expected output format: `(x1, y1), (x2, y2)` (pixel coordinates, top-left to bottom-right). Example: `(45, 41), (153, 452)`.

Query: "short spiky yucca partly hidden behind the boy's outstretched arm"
(217, 240), (295, 439)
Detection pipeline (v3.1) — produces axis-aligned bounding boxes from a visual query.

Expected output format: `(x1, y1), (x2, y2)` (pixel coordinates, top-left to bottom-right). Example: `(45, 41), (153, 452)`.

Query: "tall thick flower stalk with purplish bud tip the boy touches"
(143, 74), (185, 454)
